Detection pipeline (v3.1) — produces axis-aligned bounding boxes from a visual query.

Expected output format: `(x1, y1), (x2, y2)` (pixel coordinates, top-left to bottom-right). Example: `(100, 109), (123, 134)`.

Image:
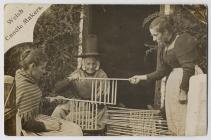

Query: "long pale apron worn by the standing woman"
(165, 67), (202, 136)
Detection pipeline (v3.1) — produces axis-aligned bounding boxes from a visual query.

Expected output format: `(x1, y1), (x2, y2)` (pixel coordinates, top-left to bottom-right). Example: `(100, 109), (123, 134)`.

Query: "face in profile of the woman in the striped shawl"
(31, 62), (46, 80)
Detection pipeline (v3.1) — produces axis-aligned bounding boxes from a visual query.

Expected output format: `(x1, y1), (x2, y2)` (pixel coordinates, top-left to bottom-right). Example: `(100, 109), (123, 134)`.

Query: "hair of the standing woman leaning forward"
(149, 15), (174, 33)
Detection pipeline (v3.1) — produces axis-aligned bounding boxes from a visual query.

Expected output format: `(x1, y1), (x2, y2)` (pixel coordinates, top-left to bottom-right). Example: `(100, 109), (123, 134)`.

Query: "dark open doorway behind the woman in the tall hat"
(91, 5), (160, 108)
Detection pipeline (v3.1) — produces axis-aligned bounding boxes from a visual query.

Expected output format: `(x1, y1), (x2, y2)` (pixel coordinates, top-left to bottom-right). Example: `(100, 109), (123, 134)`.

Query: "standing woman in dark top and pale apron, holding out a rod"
(129, 16), (201, 135)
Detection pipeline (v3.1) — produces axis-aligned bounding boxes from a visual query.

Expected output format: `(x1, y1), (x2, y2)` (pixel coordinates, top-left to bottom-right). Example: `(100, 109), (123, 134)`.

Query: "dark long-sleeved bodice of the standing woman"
(147, 33), (198, 91)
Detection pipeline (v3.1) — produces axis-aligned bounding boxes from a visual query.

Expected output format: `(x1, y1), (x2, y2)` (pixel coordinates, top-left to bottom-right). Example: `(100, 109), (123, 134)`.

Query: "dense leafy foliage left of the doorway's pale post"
(34, 4), (82, 94)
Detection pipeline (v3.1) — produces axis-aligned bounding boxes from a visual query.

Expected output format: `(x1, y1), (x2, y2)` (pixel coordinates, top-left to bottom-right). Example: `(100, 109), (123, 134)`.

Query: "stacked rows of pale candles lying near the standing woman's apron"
(105, 107), (172, 136)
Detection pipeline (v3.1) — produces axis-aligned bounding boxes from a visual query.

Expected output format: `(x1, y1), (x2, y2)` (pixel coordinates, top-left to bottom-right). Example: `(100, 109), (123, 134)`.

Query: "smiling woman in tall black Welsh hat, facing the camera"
(52, 35), (107, 128)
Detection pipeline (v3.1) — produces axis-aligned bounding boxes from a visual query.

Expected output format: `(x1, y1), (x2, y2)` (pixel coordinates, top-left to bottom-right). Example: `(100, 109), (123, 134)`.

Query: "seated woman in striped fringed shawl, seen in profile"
(15, 49), (82, 136)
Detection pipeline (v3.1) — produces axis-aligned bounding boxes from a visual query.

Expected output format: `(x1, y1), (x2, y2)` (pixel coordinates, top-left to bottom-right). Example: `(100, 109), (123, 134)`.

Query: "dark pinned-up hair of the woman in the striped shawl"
(20, 49), (47, 70)
